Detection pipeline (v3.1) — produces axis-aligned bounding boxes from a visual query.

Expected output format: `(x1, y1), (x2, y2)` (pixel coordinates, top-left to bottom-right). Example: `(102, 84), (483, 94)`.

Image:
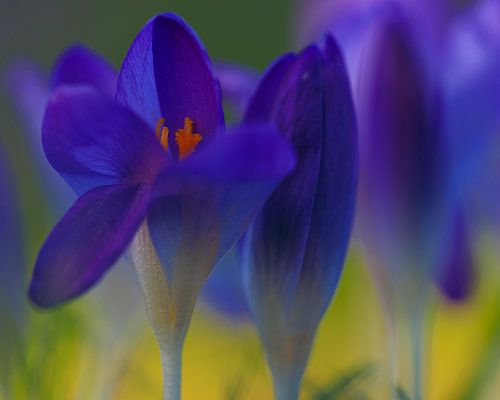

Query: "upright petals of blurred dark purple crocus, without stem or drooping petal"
(357, 10), (458, 296)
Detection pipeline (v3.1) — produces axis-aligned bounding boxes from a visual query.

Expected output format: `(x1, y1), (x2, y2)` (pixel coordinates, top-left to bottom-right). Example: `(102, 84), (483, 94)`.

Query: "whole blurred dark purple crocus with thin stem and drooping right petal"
(356, 8), (472, 399)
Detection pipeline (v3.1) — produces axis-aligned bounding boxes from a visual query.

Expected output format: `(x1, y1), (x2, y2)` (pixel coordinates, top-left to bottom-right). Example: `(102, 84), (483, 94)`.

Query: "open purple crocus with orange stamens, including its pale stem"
(30, 14), (294, 399)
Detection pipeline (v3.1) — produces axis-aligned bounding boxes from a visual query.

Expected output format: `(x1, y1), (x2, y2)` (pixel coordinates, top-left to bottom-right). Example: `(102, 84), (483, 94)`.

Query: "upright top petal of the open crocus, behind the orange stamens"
(117, 14), (224, 157)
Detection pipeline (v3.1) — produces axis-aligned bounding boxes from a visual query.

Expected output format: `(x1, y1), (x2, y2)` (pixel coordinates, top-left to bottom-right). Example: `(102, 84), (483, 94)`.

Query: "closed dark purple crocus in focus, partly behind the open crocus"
(244, 36), (357, 400)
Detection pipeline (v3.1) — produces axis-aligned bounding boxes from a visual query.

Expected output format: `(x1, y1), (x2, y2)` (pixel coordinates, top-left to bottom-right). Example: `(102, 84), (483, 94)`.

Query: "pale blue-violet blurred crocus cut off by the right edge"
(441, 0), (500, 232)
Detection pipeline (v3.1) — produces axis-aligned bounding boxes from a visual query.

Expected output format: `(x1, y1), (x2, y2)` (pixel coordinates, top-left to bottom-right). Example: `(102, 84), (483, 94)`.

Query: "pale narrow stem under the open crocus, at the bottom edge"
(160, 345), (182, 400)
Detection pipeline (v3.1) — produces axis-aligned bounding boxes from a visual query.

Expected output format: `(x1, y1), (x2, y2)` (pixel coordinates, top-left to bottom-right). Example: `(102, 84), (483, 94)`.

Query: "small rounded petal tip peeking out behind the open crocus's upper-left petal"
(50, 45), (117, 98)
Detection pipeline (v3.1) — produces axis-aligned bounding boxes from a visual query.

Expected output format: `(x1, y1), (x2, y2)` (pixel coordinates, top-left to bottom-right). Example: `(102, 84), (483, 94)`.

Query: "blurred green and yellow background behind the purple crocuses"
(0, 0), (500, 400)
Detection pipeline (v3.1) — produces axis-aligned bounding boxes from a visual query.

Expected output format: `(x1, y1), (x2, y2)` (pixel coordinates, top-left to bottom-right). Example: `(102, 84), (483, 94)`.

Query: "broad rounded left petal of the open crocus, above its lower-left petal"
(43, 86), (167, 194)
